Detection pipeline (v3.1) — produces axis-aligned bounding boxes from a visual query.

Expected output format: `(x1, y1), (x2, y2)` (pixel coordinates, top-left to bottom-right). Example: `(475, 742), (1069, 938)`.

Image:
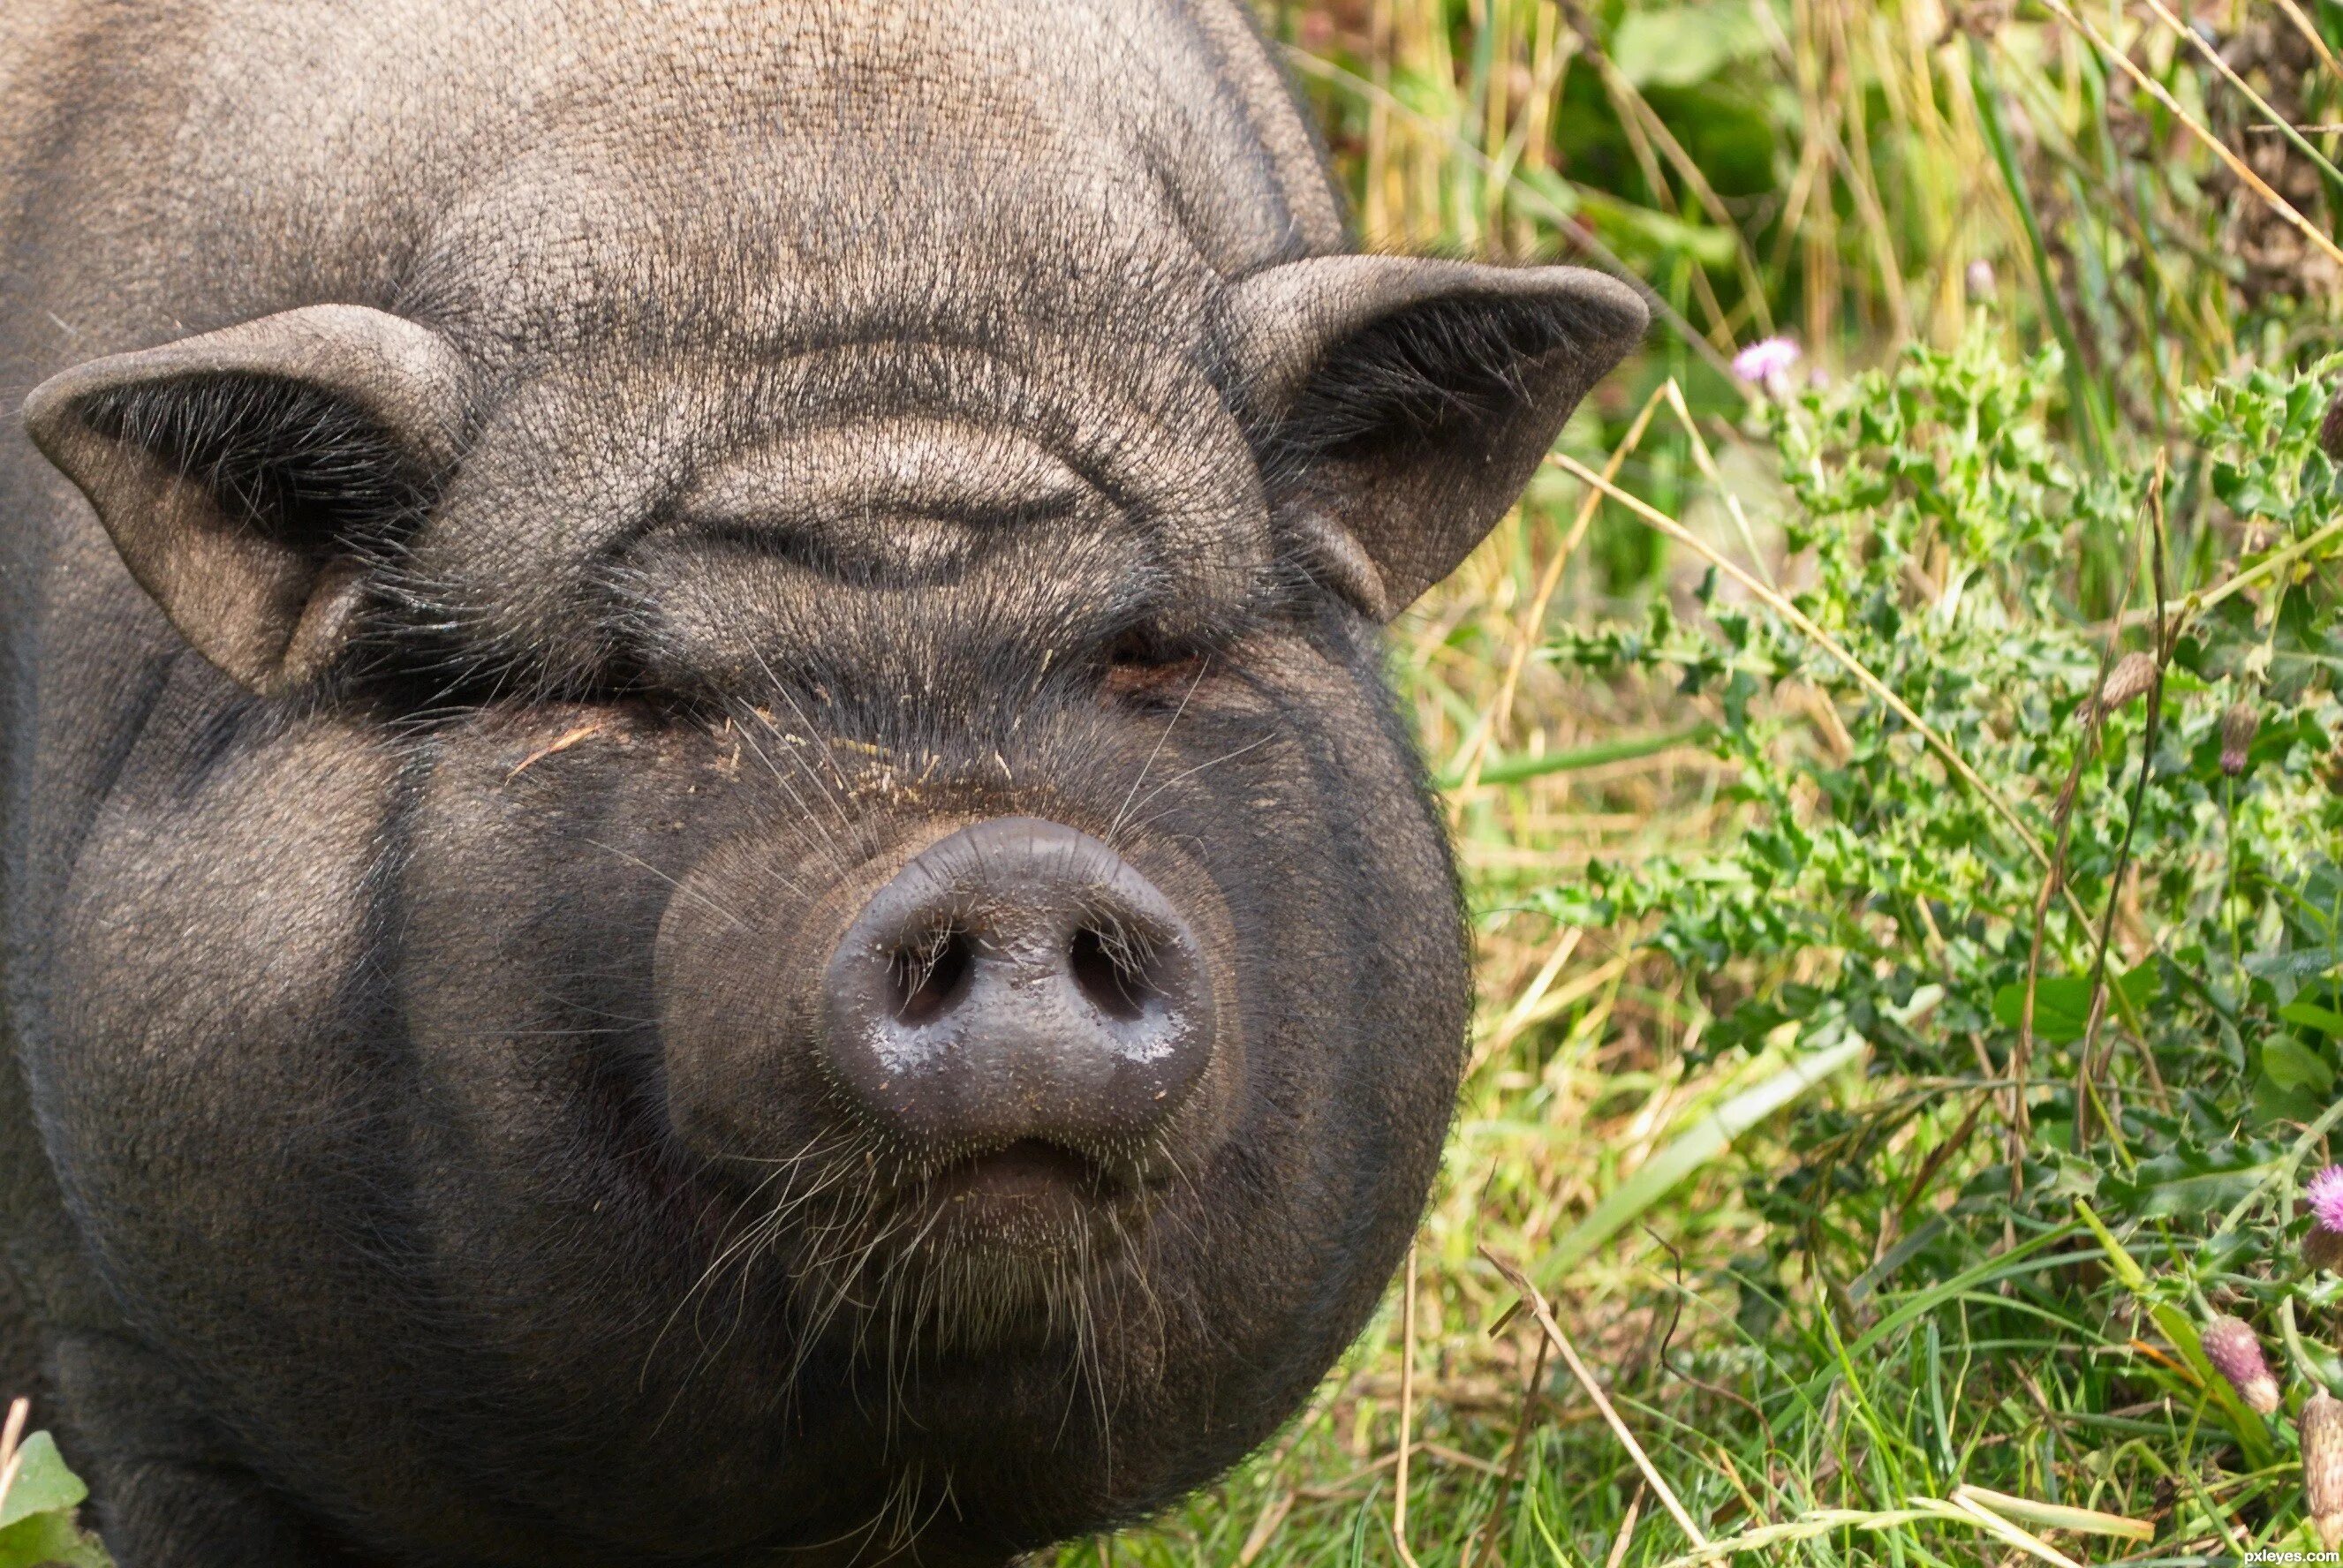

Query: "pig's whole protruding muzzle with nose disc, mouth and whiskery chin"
(658, 806), (1242, 1347)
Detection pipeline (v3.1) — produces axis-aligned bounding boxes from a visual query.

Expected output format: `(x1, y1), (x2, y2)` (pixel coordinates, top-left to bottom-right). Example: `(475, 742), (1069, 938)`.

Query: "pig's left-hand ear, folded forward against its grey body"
(24, 305), (469, 694)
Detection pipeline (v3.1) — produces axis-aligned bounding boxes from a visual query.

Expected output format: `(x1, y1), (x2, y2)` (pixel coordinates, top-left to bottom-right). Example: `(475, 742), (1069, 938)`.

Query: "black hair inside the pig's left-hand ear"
(82, 373), (428, 560)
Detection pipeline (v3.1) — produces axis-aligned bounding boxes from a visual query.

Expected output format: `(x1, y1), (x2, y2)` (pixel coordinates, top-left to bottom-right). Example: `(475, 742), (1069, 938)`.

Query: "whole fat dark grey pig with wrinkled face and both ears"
(0, 0), (1644, 1568)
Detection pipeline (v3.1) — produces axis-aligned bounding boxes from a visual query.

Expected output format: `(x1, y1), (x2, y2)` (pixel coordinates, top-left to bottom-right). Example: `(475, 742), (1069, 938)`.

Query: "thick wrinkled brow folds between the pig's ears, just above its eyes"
(412, 335), (1270, 684)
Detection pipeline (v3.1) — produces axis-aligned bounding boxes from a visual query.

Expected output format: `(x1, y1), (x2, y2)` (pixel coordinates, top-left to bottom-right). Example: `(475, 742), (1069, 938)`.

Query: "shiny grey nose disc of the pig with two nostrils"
(820, 816), (1213, 1156)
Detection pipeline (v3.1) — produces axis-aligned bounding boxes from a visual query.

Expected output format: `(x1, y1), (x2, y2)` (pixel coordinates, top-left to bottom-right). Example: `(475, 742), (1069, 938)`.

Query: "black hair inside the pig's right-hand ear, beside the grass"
(1270, 298), (1579, 473)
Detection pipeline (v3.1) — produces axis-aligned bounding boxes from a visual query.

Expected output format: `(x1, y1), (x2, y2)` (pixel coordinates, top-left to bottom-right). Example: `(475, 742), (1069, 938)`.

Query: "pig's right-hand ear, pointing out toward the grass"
(1221, 255), (1650, 621)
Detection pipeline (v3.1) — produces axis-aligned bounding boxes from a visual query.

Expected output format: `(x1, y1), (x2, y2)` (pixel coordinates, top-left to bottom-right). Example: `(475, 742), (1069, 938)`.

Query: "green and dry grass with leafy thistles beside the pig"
(1057, 0), (2343, 1568)
